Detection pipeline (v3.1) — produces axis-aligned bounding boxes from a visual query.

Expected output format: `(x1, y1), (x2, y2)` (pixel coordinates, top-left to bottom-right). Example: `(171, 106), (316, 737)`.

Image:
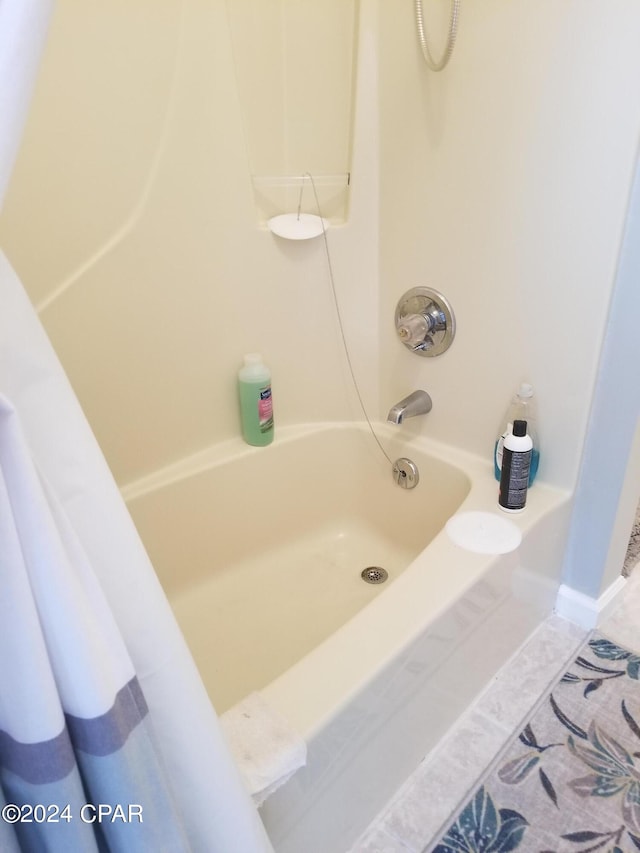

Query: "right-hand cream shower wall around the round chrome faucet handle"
(379, 0), (640, 496)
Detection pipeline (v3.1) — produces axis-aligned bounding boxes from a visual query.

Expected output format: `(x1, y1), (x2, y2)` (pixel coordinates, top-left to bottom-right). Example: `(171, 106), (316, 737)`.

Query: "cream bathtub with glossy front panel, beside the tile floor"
(123, 424), (568, 853)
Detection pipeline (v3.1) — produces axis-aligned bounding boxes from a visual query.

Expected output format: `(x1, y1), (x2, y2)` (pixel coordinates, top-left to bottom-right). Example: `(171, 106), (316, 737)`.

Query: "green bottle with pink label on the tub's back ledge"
(238, 352), (274, 447)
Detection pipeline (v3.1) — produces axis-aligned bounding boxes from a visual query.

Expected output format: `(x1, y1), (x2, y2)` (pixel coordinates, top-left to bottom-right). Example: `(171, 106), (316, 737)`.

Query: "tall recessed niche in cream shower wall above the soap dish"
(227, 0), (358, 226)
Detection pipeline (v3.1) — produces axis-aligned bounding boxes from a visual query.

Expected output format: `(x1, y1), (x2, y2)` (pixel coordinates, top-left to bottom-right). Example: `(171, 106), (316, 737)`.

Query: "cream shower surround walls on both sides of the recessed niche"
(0, 0), (640, 544)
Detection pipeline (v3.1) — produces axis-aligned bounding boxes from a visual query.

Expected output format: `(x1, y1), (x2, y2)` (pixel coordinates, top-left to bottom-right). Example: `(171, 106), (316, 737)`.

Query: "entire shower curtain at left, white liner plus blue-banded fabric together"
(0, 0), (272, 853)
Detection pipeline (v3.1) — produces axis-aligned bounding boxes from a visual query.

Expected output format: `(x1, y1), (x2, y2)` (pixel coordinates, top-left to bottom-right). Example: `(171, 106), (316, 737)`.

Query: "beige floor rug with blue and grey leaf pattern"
(429, 634), (640, 853)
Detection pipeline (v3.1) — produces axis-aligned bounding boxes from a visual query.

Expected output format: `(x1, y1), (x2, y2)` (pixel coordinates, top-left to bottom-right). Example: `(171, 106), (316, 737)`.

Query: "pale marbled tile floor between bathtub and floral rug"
(349, 552), (640, 853)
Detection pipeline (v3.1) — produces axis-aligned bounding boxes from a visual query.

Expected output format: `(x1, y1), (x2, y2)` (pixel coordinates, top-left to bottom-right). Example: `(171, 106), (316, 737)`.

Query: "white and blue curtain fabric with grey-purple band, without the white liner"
(0, 395), (188, 853)
